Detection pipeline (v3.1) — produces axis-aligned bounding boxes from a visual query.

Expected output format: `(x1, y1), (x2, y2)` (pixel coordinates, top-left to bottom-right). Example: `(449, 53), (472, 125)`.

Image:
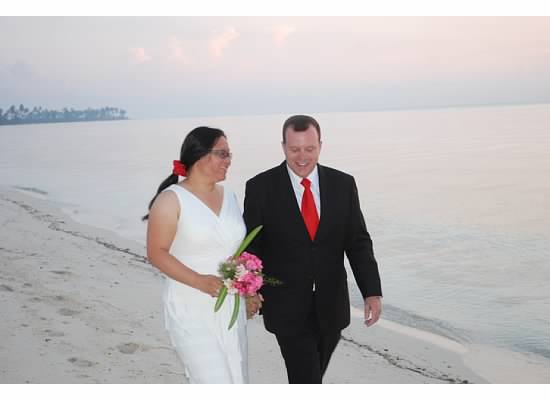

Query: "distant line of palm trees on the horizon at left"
(0, 104), (128, 125)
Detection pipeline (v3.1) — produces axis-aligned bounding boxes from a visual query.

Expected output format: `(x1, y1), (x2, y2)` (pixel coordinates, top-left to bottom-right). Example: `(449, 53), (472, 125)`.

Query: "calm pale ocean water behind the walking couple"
(0, 105), (550, 365)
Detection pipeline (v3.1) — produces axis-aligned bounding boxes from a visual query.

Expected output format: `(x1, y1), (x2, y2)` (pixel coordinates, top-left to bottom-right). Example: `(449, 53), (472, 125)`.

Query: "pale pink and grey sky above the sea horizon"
(0, 12), (550, 118)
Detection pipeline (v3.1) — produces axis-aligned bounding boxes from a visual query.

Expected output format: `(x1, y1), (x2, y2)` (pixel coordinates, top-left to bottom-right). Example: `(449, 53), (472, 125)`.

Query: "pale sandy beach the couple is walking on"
(0, 188), (506, 383)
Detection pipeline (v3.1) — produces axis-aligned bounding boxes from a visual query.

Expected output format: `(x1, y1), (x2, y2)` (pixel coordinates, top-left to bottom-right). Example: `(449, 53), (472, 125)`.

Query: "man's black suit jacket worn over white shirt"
(244, 162), (382, 335)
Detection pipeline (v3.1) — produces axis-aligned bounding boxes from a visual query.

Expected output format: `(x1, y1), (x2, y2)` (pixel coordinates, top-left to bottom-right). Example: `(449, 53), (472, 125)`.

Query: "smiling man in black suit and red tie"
(244, 115), (382, 383)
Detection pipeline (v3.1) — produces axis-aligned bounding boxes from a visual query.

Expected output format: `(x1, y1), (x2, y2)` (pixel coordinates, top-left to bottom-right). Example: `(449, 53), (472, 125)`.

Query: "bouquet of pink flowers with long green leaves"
(214, 225), (279, 329)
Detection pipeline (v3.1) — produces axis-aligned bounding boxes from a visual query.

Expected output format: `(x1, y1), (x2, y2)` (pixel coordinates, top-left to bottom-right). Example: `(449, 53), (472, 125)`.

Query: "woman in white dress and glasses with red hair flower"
(144, 127), (259, 383)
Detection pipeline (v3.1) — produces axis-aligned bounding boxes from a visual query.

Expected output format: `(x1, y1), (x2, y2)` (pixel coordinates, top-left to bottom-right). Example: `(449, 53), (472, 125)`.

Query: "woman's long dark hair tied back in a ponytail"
(141, 126), (226, 221)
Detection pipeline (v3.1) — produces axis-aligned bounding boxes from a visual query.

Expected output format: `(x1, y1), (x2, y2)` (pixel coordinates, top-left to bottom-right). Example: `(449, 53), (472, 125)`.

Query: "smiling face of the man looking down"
(283, 125), (321, 178)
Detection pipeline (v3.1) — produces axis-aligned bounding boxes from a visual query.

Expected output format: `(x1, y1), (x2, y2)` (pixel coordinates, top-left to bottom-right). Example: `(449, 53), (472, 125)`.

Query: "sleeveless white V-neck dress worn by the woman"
(164, 185), (248, 383)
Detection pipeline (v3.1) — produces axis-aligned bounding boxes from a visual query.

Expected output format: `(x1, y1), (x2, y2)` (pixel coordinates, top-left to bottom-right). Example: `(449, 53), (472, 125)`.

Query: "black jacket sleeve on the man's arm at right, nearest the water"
(345, 178), (382, 298)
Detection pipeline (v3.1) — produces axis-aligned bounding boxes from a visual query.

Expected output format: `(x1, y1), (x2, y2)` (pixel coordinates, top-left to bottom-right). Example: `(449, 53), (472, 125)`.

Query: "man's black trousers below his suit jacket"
(275, 299), (341, 383)
